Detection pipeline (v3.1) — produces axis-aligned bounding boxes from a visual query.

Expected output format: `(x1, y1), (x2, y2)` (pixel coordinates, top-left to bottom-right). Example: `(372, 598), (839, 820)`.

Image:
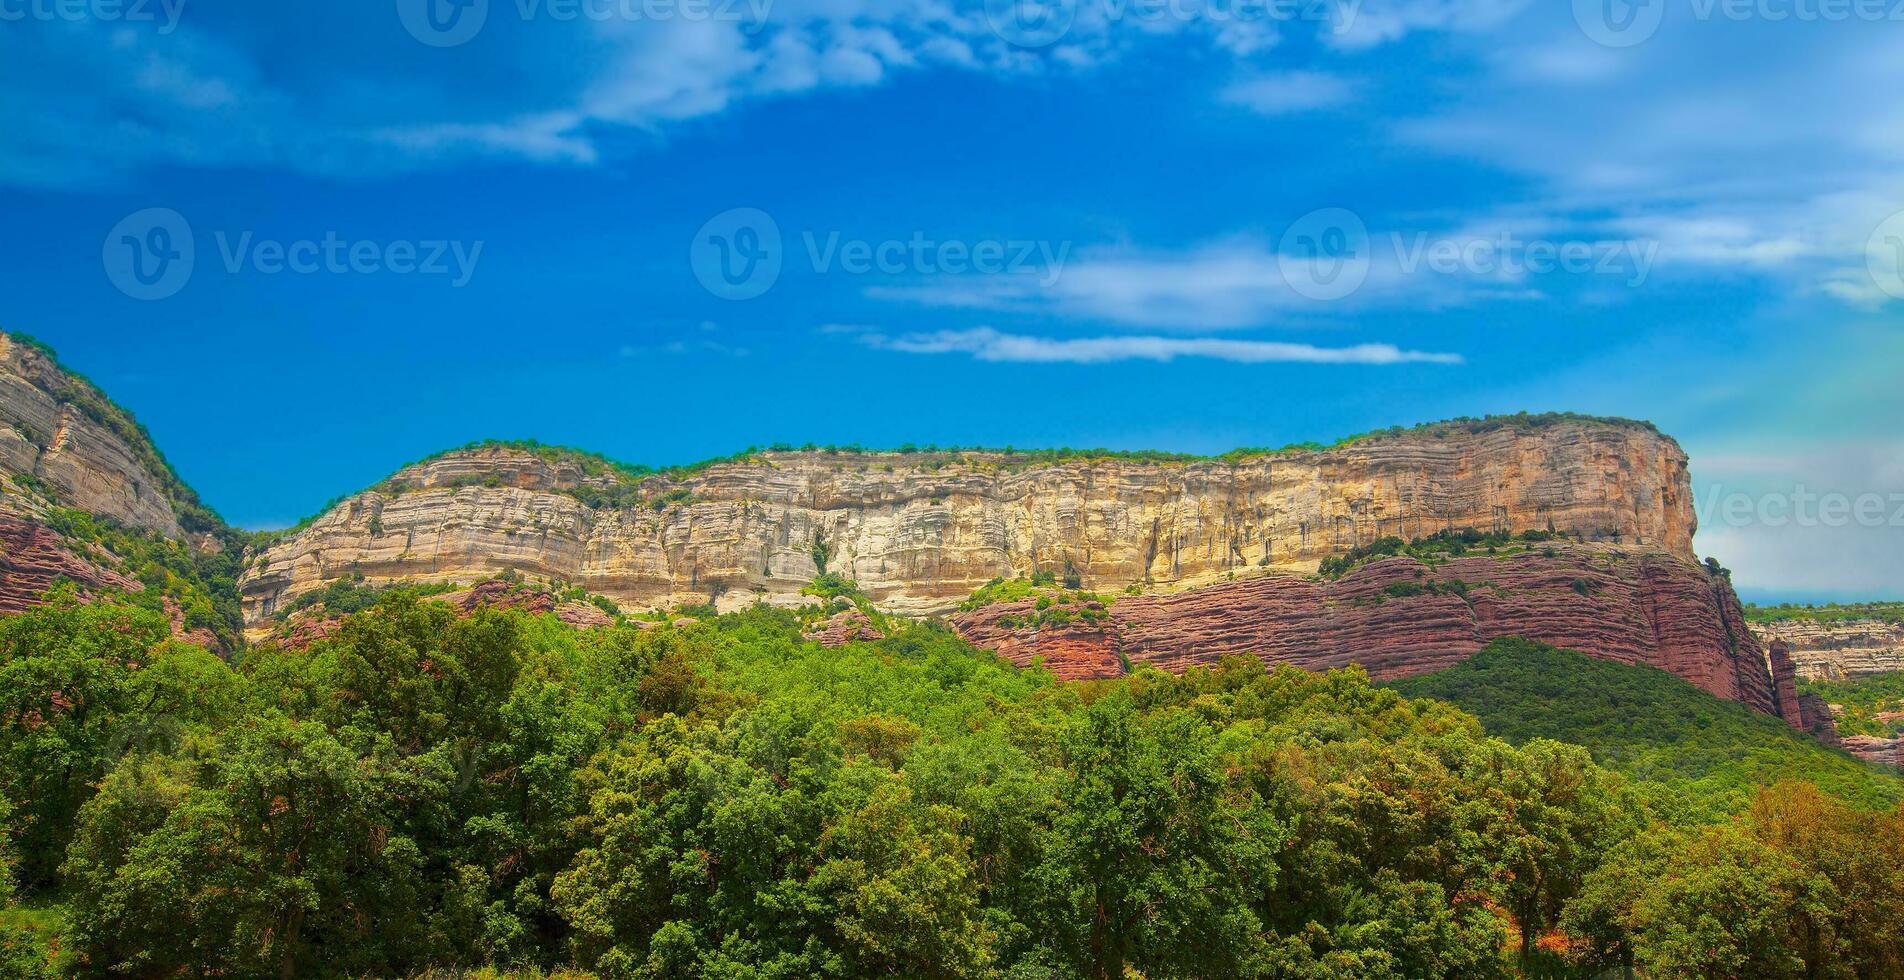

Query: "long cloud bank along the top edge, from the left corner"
(0, 0), (1546, 186)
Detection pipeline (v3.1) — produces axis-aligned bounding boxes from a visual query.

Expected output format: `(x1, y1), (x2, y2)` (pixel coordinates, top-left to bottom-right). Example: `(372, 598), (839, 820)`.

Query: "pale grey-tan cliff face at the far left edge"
(0, 333), (181, 537)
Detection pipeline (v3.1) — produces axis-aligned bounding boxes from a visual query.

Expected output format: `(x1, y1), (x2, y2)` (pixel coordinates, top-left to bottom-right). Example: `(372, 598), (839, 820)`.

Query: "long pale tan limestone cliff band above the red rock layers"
(242, 421), (1695, 620)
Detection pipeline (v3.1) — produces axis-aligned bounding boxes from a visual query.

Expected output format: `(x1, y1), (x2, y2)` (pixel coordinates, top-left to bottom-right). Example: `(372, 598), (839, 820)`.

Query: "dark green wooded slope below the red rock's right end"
(1390, 639), (1904, 814)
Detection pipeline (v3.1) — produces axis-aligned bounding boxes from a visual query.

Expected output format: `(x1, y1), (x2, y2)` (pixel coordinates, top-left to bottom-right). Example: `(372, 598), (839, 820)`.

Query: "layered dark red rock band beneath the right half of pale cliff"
(950, 544), (1807, 711)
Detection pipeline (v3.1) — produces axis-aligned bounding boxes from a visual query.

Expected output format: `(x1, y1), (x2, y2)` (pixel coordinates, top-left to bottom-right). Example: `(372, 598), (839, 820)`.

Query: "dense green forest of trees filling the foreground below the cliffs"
(0, 597), (1904, 978)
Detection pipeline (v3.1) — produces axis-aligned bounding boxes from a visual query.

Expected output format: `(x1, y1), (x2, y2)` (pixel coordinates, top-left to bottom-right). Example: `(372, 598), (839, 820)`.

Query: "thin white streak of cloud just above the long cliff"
(821, 323), (1462, 365)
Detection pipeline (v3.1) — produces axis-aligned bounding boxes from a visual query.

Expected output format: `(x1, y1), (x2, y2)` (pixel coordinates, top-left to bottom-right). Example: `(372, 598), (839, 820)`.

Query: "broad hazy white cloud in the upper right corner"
(1394, 4), (1904, 306)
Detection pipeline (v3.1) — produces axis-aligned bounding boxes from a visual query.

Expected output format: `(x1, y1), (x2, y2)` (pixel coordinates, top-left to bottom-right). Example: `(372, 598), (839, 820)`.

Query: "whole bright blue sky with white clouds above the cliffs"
(0, 0), (1904, 599)
